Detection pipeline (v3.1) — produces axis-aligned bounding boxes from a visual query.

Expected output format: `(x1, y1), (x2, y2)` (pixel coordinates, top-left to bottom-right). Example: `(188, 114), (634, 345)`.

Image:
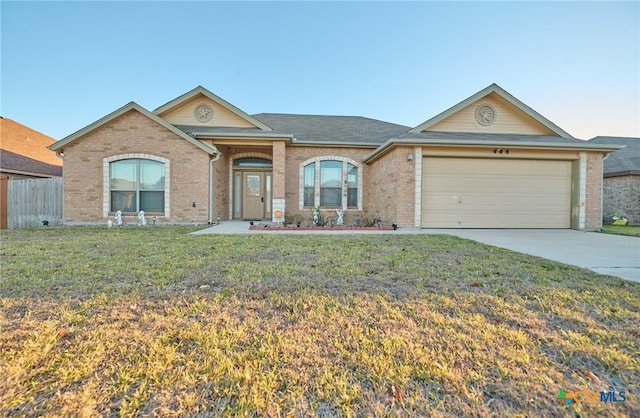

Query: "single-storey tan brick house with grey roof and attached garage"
(50, 84), (621, 230)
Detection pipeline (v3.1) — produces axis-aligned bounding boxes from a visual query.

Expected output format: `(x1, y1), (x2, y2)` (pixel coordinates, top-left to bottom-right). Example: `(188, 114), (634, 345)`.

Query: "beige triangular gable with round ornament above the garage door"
(410, 83), (573, 138)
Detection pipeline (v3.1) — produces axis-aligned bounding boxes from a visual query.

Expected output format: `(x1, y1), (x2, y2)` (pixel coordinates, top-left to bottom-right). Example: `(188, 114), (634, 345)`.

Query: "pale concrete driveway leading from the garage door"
(429, 229), (640, 282)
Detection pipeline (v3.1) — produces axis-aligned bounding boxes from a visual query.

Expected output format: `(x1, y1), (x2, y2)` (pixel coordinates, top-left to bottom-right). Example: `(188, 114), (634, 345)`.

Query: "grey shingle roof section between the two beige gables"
(253, 113), (411, 146)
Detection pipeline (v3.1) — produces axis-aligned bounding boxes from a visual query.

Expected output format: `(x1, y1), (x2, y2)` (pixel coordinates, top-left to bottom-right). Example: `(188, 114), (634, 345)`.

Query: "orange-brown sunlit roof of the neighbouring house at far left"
(0, 117), (62, 177)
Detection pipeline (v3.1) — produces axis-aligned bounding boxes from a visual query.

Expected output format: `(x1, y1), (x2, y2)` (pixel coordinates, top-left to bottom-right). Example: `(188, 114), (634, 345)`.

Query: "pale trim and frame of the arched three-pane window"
(298, 155), (363, 210)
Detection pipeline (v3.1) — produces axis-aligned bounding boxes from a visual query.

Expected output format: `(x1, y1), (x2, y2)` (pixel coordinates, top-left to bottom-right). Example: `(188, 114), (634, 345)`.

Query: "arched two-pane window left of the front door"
(109, 159), (165, 212)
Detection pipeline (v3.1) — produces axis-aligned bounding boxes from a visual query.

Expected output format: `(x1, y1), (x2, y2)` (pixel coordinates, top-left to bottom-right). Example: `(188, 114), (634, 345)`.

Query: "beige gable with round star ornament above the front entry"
(153, 86), (271, 131)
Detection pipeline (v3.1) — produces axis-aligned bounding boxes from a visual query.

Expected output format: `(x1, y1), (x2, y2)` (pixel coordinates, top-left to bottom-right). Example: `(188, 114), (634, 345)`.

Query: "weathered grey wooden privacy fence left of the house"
(0, 177), (63, 229)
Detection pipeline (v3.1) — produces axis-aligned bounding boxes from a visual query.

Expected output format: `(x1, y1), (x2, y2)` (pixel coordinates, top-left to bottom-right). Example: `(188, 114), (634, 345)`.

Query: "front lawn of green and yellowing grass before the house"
(0, 227), (640, 417)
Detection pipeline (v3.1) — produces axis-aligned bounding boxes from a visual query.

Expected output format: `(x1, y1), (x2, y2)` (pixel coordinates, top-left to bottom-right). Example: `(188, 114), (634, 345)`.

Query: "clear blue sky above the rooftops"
(0, 1), (640, 139)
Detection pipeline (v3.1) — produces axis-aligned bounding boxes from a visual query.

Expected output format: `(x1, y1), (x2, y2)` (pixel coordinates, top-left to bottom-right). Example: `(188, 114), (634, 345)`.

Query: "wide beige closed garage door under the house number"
(422, 157), (571, 228)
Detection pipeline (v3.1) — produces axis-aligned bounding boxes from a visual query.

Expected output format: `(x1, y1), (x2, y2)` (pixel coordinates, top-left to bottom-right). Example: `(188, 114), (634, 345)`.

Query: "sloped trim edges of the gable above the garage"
(411, 83), (573, 138)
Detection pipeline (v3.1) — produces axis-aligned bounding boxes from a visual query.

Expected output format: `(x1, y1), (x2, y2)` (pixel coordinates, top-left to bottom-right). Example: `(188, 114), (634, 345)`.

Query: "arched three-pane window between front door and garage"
(300, 157), (361, 209)
